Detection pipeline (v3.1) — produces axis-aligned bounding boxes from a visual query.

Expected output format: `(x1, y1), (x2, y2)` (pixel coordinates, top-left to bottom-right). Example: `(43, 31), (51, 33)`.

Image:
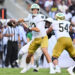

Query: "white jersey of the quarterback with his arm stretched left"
(24, 14), (47, 38)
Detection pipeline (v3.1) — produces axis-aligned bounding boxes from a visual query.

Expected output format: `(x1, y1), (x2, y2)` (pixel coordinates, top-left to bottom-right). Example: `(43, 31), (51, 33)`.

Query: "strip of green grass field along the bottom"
(0, 68), (69, 75)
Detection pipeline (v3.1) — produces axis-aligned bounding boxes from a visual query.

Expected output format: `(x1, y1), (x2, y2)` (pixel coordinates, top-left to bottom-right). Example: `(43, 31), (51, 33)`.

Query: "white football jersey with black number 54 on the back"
(52, 20), (70, 39)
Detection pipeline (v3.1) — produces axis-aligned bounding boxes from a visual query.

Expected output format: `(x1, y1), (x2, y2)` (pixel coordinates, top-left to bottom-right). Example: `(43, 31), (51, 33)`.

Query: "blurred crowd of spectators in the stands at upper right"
(32, 0), (75, 20)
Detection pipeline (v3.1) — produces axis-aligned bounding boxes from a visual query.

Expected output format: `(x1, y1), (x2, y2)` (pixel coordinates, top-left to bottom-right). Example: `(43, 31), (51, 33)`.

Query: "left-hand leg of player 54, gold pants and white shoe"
(52, 38), (65, 73)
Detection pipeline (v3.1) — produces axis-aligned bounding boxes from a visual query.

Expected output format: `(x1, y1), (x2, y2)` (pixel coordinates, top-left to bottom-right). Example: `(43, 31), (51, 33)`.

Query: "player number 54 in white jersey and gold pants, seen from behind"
(48, 13), (75, 72)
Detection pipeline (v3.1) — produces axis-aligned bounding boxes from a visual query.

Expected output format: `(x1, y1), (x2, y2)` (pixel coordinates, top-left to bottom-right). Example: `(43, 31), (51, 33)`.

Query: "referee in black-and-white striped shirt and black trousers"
(3, 20), (19, 68)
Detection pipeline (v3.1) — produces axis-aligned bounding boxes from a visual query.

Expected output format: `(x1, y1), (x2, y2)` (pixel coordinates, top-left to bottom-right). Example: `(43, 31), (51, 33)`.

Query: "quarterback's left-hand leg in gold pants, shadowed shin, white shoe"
(20, 40), (39, 73)
